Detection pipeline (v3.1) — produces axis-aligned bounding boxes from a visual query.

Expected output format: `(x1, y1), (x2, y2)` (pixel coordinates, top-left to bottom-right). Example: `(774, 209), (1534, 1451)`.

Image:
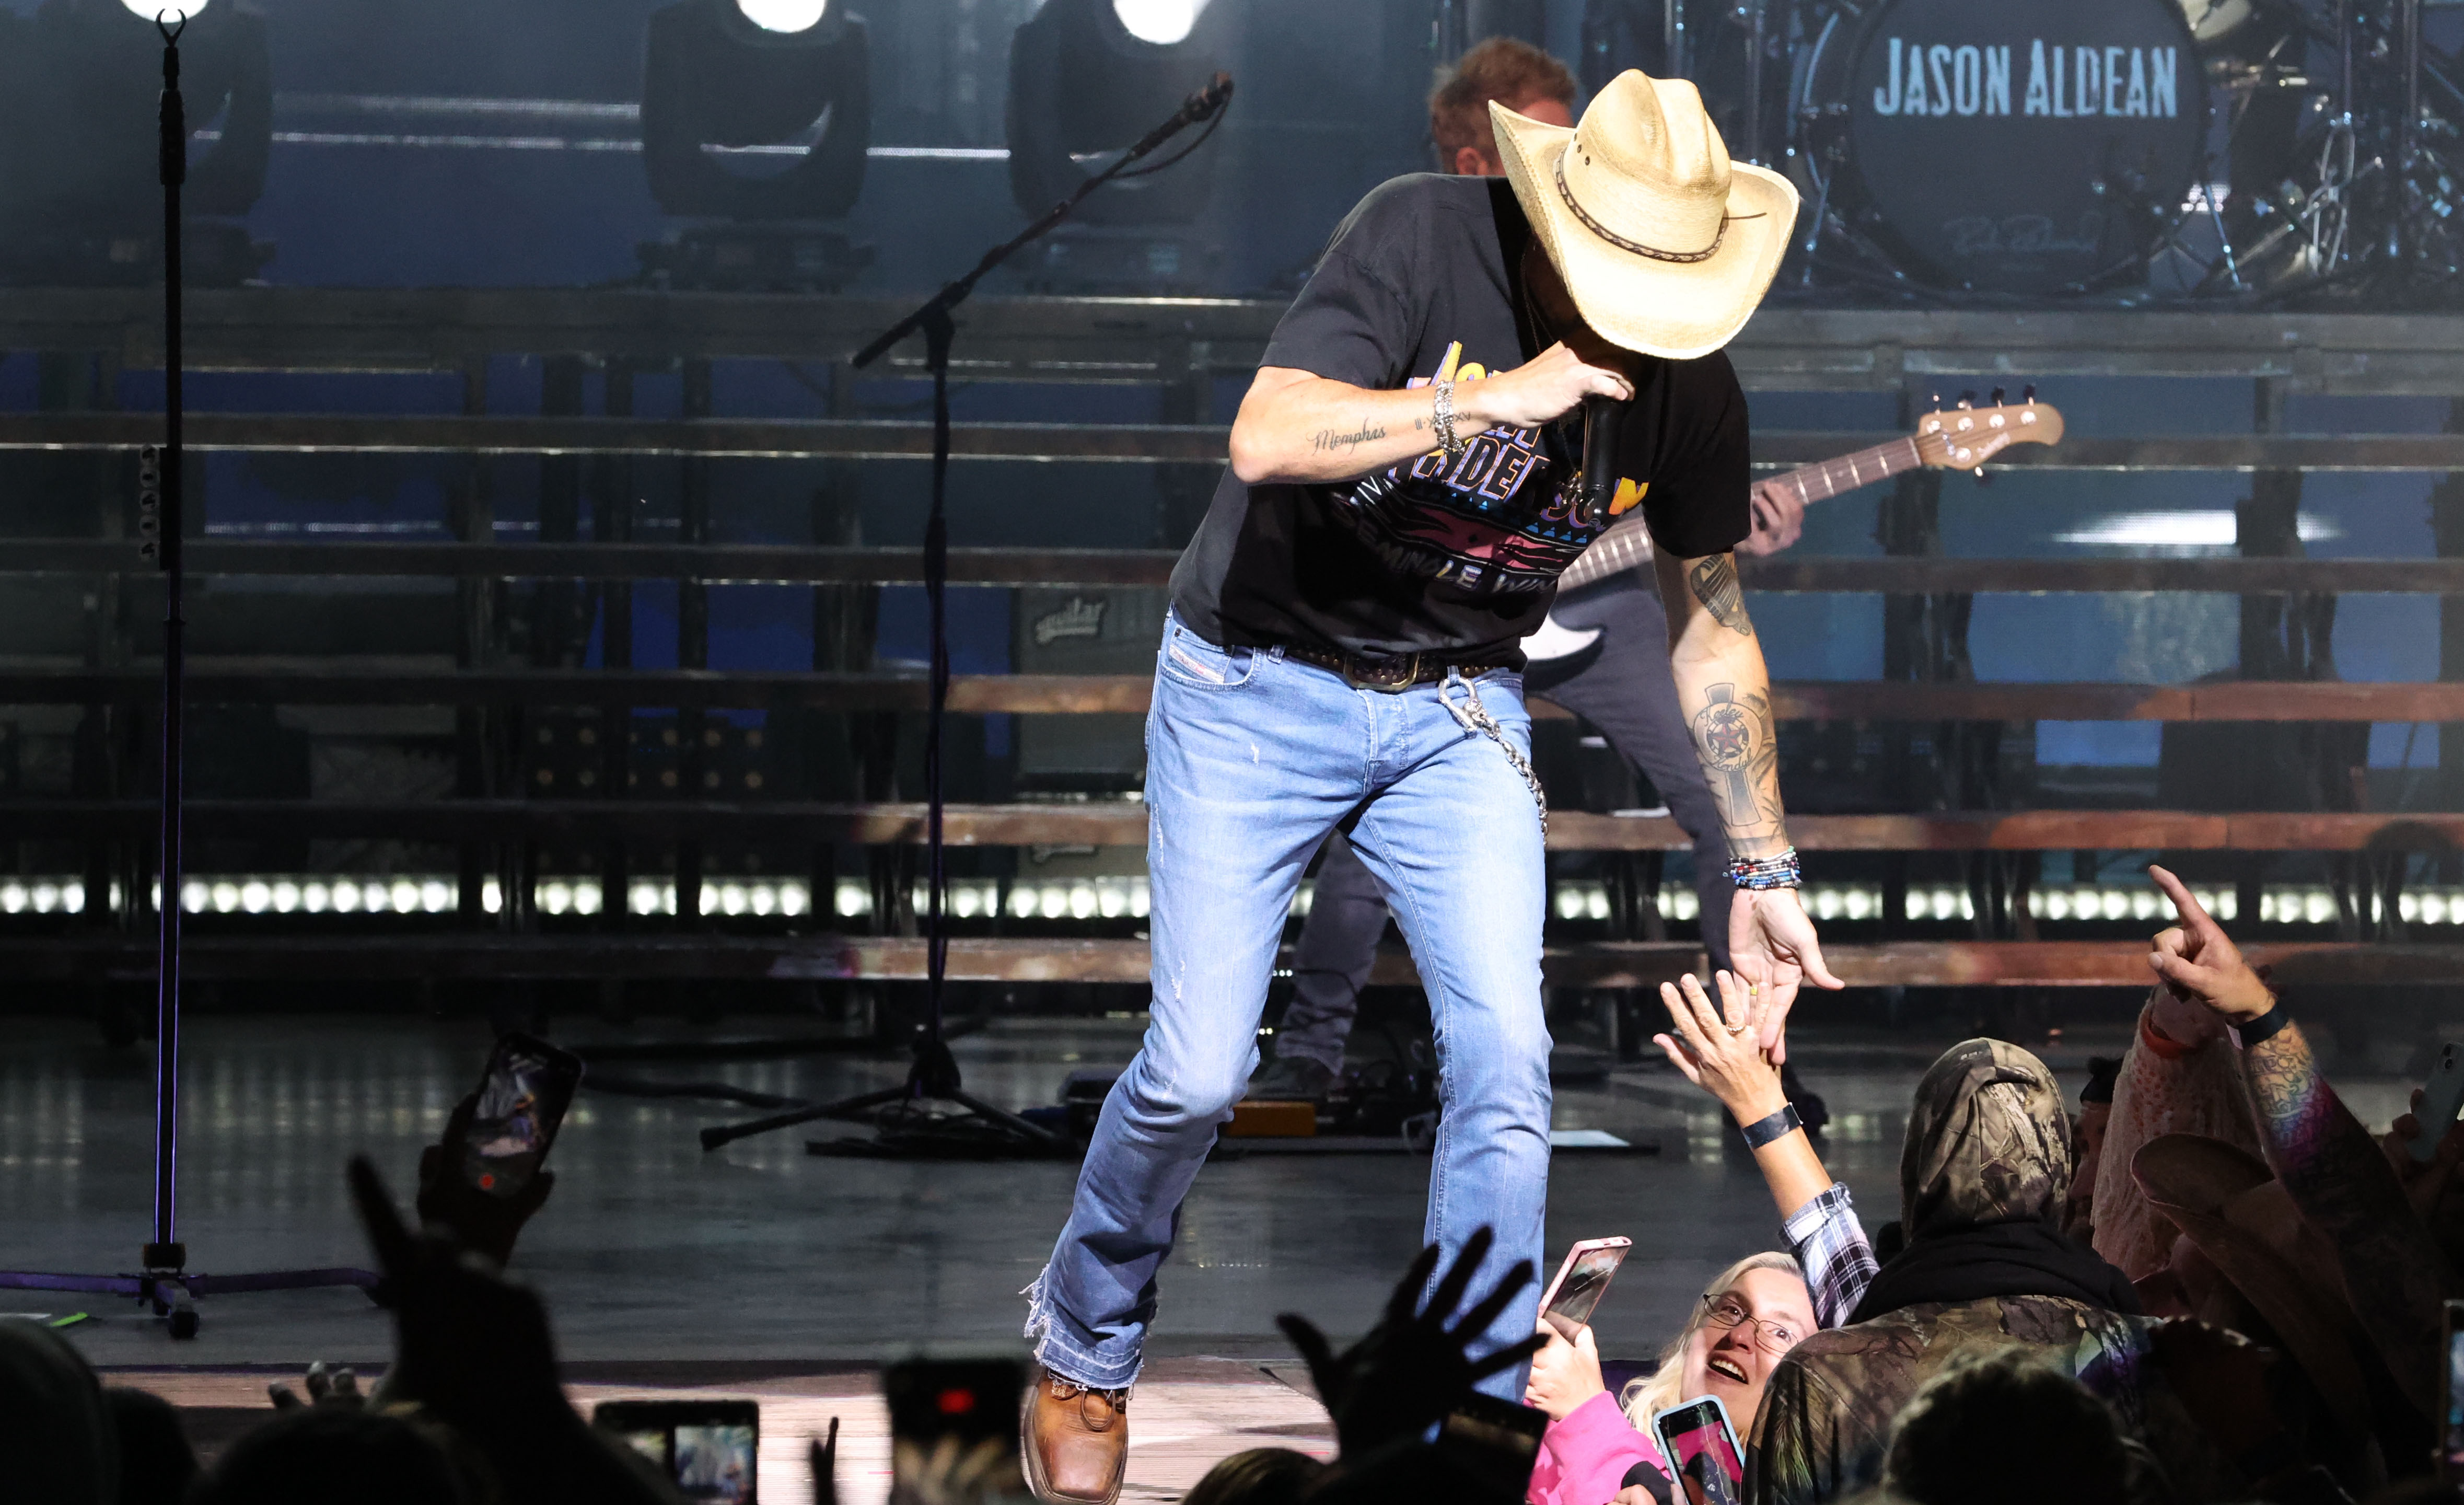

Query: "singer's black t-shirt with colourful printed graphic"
(1173, 172), (1752, 663)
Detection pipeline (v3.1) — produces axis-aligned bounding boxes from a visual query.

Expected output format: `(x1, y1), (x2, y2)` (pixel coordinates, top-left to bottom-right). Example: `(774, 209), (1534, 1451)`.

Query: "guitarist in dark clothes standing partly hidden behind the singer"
(1249, 37), (1826, 1108)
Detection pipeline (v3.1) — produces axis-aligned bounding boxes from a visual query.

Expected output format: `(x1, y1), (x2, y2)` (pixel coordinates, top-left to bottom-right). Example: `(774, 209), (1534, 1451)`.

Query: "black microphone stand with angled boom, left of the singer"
(702, 74), (1232, 1155)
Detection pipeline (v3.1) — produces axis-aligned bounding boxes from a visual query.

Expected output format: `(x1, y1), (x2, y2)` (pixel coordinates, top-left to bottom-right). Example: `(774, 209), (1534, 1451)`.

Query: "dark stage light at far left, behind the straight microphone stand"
(0, 0), (273, 286)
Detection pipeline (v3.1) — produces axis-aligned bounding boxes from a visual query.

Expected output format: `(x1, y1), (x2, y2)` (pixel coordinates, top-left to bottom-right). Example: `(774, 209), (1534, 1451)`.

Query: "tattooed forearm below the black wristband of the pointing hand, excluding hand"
(2242, 1024), (2449, 1409)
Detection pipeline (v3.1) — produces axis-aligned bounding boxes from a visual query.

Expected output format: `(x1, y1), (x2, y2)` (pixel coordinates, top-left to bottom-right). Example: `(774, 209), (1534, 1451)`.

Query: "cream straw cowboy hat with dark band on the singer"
(1488, 69), (1796, 360)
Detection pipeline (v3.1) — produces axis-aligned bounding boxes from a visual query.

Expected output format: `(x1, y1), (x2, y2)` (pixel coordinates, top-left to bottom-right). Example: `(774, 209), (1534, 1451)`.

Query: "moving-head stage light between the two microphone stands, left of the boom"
(641, 0), (872, 291)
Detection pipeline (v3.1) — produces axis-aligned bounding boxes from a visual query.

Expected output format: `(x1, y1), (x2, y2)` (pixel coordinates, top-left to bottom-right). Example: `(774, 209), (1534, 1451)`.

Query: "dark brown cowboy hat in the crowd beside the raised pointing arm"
(2131, 1133), (2368, 1431)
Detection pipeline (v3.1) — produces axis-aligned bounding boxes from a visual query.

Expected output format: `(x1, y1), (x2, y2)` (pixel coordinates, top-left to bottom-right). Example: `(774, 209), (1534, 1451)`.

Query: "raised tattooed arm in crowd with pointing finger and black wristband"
(2148, 867), (2457, 1416)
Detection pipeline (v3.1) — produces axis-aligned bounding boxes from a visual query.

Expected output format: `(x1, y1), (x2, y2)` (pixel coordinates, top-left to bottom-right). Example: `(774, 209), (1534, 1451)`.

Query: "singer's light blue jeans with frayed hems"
(1028, 618), (1550, 1399)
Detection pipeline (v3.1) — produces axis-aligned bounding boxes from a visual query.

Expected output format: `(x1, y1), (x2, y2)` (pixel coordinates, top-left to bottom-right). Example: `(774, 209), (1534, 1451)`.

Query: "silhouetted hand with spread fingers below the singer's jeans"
(1274, 1226), (1540, 1458)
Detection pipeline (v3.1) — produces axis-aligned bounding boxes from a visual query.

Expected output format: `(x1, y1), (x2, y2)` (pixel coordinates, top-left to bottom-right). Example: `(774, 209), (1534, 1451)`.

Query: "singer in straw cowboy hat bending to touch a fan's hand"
(1022, 74), (1841, 1505)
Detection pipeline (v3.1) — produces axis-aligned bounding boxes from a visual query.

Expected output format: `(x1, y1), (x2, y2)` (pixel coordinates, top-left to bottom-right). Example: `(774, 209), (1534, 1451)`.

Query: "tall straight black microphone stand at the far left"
(0, 13), (377, 1337)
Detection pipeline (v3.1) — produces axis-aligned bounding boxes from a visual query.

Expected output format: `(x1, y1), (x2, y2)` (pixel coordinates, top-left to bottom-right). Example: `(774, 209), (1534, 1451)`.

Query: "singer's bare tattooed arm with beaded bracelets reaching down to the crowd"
(1651, 554), (1845, 1044)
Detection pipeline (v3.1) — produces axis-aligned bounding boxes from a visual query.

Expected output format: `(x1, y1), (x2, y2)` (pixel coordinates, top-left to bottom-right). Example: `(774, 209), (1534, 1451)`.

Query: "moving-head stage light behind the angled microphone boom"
(1008, 0), (1232, 293)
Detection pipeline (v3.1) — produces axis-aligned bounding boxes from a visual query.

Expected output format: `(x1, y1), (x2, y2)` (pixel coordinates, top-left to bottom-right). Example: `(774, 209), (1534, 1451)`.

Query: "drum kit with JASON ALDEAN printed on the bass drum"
(1616, 0), (2464, 308)
